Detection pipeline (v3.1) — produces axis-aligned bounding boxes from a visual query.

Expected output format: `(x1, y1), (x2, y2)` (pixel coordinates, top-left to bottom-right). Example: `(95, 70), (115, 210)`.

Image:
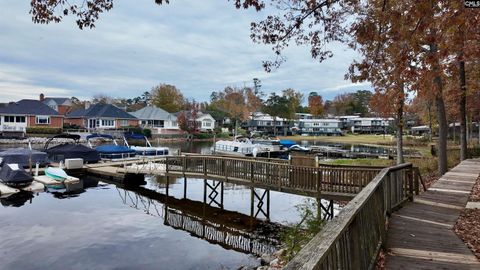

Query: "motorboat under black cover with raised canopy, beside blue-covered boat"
(44, 134), (100, 163)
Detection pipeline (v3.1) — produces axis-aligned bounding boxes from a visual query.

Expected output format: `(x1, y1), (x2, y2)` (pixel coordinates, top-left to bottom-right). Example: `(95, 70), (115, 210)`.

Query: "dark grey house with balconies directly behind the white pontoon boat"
(243, 112), (290, 135)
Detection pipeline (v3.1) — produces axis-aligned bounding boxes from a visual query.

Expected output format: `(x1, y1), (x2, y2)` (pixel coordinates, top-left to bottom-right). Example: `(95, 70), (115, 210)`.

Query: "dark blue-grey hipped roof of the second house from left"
(67, 103), (136, 119)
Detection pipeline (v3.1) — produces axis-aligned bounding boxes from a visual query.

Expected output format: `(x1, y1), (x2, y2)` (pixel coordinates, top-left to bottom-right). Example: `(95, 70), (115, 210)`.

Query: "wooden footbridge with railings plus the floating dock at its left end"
(84, 155), (381, 200)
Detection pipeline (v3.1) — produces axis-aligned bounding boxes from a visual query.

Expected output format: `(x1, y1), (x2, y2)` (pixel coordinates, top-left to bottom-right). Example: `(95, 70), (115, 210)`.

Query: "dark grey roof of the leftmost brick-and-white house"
(0, 99), (59, 115)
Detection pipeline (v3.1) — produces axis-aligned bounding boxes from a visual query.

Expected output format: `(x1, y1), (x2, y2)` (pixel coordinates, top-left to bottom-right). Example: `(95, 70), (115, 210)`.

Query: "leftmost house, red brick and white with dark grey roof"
(0, 99), (63, 133)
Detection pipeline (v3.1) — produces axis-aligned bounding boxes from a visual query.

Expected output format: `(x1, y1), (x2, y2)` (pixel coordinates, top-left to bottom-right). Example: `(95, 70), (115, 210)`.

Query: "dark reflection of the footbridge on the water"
(118, 188), (279, 256)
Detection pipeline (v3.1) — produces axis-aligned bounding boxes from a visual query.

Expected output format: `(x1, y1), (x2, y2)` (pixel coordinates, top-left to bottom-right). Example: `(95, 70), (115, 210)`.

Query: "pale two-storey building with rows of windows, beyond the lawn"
(298, 119), (342, 135)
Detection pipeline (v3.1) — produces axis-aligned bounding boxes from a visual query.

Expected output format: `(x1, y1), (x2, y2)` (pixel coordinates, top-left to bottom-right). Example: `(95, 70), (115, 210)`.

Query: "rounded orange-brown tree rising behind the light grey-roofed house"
(150, 84), (185, 113)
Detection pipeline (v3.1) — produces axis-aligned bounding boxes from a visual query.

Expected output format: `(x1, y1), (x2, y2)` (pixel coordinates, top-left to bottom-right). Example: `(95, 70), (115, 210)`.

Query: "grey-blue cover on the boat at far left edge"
(0, 148), (50, 168)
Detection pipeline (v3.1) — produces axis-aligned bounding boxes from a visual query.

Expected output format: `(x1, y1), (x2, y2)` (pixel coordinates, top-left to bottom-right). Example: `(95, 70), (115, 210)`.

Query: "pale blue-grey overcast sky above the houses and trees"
(0, 0), (370, 102)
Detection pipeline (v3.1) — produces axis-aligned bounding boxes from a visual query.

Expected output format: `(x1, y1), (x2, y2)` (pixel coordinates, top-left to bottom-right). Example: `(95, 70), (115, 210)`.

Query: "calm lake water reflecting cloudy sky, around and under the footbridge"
(0, 143), (326, 270)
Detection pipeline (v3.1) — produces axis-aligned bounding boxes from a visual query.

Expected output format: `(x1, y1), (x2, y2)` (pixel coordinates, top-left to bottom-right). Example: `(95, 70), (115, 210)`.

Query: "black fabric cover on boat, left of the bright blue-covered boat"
(46, 143), (100, 163)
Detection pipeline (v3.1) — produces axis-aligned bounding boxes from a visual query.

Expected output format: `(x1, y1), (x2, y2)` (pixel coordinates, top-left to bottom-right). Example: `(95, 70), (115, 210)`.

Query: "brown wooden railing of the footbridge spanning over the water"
(165, 155), (381, 196)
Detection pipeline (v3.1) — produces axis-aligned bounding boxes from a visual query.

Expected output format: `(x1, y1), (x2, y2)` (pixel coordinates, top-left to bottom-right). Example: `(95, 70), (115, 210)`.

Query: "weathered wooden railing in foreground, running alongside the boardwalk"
(284, 163), (418, 270)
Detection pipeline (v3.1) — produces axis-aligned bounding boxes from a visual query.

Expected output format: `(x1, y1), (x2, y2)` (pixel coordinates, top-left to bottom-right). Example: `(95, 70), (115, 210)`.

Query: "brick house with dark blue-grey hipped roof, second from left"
(65, 103), (139, 129)
